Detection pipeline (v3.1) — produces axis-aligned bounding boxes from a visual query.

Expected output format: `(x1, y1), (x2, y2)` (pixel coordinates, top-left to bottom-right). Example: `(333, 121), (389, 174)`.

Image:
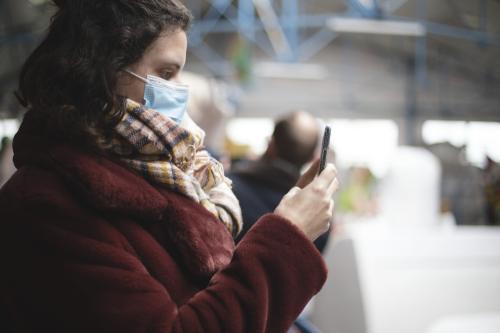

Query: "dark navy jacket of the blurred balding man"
(228, 156), (330, 252)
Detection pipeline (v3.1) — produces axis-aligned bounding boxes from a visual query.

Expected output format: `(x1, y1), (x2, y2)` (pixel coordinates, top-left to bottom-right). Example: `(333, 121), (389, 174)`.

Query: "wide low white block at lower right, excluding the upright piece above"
(312, 224), (500, 333)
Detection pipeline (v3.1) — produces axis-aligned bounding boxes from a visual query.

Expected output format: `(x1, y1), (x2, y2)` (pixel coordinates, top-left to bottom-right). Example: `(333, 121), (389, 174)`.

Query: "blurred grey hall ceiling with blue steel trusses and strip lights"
(0, 0), (500, 126)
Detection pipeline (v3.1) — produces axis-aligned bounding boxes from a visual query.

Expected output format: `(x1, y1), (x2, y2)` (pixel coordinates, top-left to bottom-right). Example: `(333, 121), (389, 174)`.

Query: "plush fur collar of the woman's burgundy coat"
(14, 111), (234, 279)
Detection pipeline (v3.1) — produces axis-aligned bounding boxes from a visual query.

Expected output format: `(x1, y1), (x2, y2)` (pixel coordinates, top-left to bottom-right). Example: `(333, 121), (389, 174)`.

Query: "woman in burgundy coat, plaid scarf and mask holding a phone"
(0, 0), (338, 333)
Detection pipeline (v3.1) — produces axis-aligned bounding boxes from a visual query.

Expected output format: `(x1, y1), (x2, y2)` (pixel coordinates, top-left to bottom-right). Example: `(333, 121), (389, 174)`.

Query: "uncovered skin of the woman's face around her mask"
(117, 29), (187, 103)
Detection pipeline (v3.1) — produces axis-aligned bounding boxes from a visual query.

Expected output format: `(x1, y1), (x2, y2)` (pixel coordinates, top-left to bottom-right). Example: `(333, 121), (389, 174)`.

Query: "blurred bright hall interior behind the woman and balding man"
(0, 0), (500, 333)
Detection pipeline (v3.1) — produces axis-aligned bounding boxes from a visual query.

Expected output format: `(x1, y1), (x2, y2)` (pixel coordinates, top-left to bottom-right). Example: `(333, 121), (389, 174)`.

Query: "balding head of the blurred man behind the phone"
(272, 111), (319, 168)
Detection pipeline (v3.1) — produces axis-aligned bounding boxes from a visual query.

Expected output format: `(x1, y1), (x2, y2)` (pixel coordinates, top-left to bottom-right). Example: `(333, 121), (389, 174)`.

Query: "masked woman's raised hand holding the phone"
(274, 163), (339, 241)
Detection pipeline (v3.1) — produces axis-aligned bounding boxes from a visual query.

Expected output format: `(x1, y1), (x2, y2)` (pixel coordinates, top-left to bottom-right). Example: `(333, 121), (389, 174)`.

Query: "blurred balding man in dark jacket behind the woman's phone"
(228, 111), (328, 252)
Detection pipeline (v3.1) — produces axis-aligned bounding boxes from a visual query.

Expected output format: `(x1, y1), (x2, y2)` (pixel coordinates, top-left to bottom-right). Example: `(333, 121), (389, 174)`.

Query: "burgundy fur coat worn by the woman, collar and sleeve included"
(0, 113), (326, 333)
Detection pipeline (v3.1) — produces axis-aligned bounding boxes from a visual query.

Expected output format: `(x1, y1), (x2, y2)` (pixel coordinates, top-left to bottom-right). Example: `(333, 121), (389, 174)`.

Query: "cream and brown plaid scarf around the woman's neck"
(100, 100), (242, 237)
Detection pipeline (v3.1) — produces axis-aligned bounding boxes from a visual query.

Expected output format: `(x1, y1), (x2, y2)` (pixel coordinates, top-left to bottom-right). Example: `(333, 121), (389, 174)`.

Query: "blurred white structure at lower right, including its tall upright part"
(312, 148), (500, 333)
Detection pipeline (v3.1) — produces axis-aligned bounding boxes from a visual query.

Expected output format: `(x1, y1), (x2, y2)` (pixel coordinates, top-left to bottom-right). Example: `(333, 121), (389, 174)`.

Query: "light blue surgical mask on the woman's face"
(125, 70), (189, 124)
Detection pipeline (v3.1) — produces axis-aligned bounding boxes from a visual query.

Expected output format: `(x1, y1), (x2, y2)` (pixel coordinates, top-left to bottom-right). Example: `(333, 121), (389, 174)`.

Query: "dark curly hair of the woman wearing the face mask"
(16, 0), (192, 145)
